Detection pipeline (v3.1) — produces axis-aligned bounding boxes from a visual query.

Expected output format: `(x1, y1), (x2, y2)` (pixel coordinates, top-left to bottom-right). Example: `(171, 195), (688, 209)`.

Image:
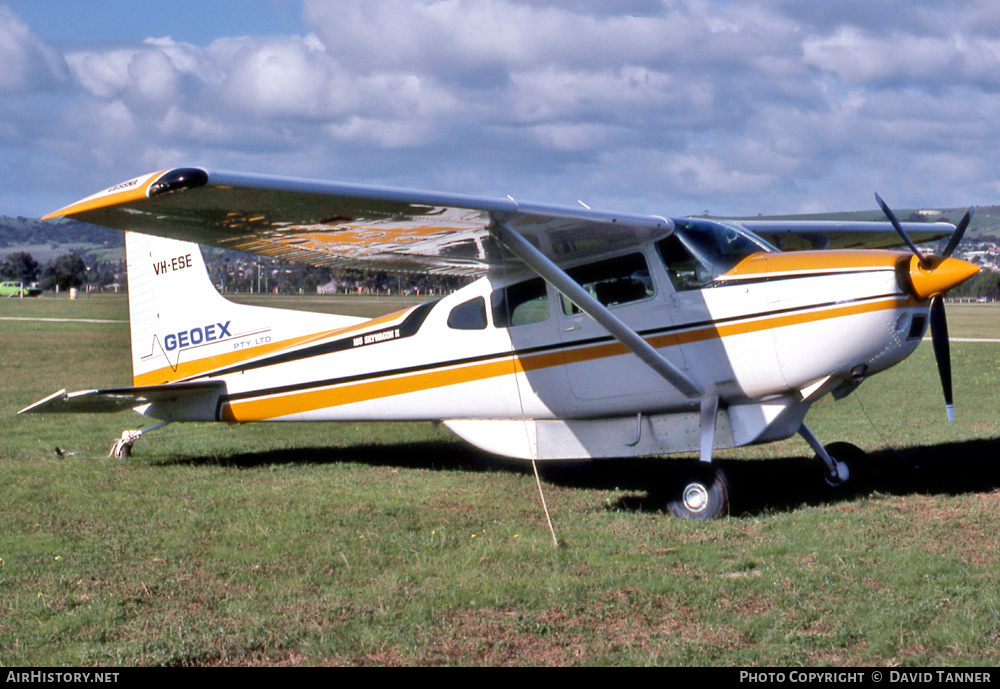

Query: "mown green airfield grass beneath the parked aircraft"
(0, 296), (1000, 666)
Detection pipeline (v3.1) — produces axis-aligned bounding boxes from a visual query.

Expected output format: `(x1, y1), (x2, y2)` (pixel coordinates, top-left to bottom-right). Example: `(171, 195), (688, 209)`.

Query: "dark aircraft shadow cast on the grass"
(171, 438), (1000, 516)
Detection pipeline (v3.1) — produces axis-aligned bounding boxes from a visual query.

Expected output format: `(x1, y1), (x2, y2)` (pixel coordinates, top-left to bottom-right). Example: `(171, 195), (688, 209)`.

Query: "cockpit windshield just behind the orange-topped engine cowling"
(656, 219), (773, 292)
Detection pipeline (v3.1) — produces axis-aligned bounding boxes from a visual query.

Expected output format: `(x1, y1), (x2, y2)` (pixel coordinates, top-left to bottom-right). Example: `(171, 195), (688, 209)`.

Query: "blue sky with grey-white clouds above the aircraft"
(0, 0), (1000, 216)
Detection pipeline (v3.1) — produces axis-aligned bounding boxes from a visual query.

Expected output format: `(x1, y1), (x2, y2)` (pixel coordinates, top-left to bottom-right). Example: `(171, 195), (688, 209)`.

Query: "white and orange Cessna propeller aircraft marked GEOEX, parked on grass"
(22, 168), (977, 519)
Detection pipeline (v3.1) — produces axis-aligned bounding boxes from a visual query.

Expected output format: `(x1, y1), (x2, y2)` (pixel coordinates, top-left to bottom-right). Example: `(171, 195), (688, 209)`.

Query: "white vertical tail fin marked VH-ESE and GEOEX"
(125, 232), (366, 385)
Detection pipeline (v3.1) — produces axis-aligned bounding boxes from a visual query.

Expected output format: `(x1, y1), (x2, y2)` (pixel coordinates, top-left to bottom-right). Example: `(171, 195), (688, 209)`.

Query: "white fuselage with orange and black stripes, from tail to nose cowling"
(146, 221), (927, 456)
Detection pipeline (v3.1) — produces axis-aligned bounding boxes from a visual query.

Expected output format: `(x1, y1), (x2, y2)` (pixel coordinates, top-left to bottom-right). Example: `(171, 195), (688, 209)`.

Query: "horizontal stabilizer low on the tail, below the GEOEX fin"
(18, 381), (226, 414)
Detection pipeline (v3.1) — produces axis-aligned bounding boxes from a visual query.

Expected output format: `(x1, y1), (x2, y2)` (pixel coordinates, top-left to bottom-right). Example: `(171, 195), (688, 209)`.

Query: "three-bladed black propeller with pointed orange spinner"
(875, 194), (979, 423)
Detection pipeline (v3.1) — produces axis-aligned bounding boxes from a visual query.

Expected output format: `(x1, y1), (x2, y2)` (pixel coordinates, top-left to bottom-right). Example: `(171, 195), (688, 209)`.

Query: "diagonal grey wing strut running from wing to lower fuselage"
(493, 222), (704, 398)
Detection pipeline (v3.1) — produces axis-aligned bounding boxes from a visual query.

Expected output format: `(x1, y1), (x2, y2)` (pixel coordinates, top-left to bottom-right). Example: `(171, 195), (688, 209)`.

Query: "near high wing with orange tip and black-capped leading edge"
(46, 168), (673, 275)
